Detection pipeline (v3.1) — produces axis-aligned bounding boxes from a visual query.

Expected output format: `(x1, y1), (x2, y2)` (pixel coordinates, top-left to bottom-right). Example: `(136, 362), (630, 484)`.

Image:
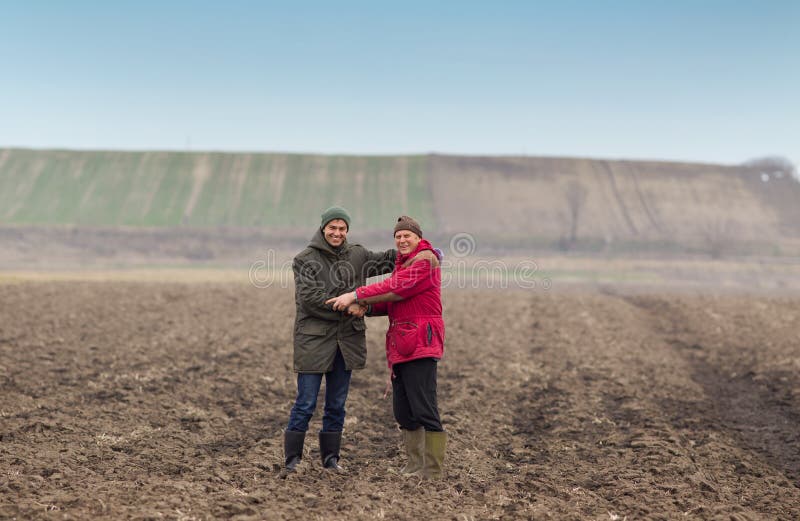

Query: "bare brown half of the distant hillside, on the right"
(430, 156), (800, 243)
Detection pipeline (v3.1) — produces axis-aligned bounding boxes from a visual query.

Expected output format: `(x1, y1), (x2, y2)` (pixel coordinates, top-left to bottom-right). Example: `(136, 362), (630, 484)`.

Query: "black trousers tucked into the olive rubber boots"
(392, 358), (442, 432)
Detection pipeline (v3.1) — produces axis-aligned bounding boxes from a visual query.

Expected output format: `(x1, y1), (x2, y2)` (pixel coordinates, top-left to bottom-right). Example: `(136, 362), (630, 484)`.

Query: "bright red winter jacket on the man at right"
(356, 239), (444, 368)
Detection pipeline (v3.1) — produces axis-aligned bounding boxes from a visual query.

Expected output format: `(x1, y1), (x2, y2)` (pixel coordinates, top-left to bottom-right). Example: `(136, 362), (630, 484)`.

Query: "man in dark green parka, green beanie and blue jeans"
(283, 206), (397, 471)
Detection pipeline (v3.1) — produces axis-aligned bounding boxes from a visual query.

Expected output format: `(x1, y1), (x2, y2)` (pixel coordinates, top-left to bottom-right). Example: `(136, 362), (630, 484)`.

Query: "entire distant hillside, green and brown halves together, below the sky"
(0, 149), (800, 250)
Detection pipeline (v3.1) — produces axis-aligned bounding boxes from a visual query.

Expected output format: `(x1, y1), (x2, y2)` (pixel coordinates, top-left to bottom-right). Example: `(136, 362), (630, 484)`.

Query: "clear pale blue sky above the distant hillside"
(0, 0), (800, 164)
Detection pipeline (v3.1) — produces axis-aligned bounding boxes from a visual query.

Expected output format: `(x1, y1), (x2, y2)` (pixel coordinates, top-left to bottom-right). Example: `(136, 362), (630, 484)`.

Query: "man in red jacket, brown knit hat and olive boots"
(327, 216), (447, 479)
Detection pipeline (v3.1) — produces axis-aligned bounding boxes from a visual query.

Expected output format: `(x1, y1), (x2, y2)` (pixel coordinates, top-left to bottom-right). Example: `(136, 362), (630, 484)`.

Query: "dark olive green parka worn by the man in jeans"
(292, 229), (397, 373)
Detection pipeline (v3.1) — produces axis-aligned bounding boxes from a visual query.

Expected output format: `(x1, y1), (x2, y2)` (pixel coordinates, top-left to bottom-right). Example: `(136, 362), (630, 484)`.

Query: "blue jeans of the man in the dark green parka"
(286, 349), (352, 432)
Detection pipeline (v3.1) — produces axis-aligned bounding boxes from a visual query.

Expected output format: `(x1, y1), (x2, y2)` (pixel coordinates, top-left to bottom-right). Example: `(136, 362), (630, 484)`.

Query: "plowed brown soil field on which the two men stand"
(0, 282), (800, 520)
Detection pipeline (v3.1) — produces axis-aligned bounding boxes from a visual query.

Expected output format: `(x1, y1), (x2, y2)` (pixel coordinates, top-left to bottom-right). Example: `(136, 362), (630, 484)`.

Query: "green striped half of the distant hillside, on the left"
(0, 150), (431, 228)
